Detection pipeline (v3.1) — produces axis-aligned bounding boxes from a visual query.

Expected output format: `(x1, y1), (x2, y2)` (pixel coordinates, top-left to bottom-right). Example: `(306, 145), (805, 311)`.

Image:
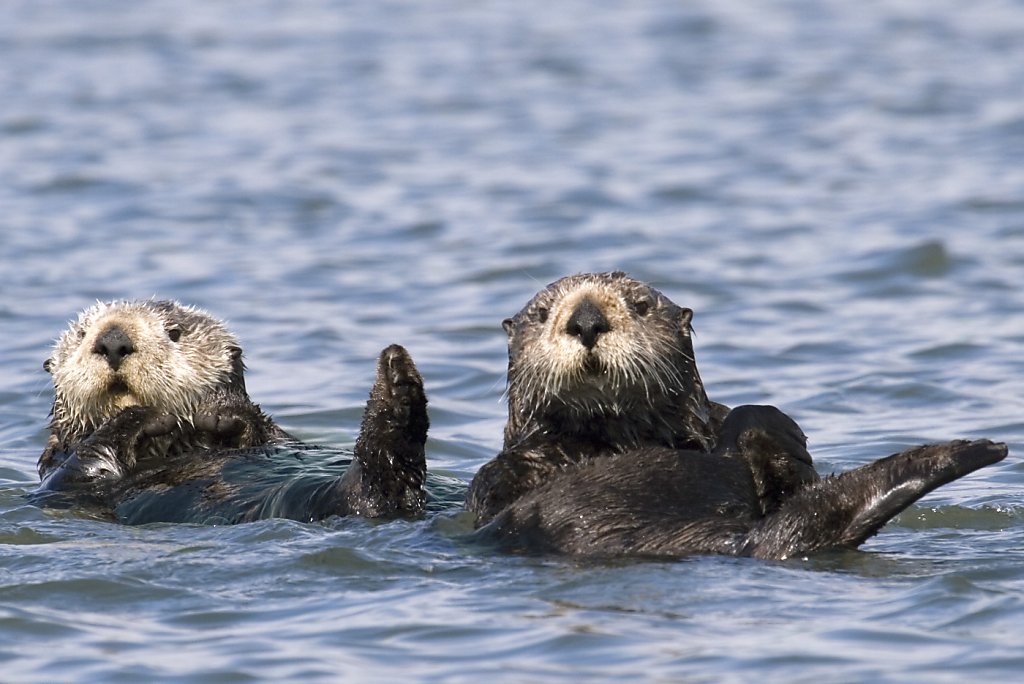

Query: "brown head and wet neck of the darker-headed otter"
(503, 272), (713, 448)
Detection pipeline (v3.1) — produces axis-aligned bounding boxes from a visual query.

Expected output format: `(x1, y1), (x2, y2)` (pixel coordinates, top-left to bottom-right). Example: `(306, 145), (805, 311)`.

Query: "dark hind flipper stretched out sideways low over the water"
(746, 439), (1007, 559)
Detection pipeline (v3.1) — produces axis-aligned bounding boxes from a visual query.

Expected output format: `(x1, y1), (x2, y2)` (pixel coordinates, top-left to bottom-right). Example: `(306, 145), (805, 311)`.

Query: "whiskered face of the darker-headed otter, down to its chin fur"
(503, 272), (703, 422)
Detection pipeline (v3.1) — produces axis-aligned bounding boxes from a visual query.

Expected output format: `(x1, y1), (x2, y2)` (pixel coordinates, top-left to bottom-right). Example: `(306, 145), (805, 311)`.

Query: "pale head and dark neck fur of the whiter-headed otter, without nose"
(38, 300), (288, 479)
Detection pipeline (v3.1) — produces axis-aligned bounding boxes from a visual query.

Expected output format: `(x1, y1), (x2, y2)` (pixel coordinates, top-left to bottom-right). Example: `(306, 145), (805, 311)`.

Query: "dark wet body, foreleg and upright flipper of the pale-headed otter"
(37, 345), (428, 524)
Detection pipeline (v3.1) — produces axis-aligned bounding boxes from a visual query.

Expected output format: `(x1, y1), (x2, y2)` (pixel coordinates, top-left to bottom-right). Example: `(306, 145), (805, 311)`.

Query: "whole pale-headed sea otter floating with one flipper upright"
(35, 301), (428, 523)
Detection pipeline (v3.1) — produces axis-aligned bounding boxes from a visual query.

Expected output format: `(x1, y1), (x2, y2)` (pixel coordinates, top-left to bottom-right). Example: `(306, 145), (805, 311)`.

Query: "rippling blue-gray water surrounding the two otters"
(0, 0), (1024, 683)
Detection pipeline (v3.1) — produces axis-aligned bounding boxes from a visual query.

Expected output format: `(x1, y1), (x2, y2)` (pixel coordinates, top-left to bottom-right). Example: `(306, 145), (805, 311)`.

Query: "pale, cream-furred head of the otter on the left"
(43, 301), (245, 442)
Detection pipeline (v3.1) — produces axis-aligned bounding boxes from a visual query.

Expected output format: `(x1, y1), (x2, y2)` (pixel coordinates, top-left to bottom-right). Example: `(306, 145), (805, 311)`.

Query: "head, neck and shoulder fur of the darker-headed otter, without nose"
(467, 271), (727, 524)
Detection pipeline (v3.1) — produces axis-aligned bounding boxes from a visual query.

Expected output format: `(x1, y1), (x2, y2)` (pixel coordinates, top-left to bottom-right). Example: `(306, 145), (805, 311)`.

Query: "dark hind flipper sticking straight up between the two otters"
(337, 344), (430, 517)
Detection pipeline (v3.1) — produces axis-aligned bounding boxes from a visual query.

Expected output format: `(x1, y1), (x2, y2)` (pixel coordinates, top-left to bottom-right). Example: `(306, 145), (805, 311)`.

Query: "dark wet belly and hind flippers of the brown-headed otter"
(479, 407), (1007, 559)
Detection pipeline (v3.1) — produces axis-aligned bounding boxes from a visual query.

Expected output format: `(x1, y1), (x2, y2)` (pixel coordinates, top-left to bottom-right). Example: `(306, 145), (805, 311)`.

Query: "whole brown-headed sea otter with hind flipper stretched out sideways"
(467, 272), (1007, 558)
